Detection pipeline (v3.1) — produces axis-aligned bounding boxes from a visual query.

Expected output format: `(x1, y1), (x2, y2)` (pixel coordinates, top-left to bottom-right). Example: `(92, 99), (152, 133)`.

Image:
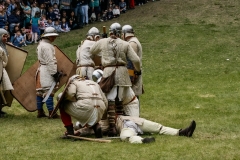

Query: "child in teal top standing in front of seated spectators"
(30, 11), (40, 43)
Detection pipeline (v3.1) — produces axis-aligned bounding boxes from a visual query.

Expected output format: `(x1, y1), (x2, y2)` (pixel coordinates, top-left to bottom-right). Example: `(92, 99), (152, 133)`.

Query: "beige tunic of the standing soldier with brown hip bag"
(90, 37), (140, 86)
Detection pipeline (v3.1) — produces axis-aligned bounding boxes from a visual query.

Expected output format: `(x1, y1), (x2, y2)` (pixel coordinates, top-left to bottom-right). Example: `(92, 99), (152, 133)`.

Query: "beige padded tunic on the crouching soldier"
(64, 79), (108, 126)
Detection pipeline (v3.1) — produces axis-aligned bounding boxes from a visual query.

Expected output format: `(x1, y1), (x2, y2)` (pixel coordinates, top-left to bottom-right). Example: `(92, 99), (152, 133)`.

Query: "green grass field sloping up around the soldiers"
(0, 0), (240, 160)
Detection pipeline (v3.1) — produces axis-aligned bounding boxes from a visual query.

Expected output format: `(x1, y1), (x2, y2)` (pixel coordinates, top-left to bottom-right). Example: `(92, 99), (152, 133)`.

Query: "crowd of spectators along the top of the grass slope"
(0, 0), (154, 47)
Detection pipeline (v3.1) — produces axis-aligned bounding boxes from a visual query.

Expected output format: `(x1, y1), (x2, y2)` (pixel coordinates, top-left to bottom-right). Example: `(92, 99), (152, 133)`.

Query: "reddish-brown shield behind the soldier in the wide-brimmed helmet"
(11, 46), (76, 112)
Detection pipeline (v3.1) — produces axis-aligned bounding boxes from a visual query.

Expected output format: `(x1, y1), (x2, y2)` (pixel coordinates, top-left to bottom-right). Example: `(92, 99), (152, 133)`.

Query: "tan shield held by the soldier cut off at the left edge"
(4, 44), (28, 107)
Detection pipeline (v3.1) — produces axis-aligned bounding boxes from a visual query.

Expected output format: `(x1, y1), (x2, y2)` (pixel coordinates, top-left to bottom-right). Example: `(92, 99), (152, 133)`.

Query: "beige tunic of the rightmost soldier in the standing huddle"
(128, 37), (143, 96)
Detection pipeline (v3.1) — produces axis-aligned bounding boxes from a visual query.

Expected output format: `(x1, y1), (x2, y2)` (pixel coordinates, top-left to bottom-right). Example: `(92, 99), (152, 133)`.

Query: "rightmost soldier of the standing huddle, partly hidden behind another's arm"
(122, 25), (143, 111)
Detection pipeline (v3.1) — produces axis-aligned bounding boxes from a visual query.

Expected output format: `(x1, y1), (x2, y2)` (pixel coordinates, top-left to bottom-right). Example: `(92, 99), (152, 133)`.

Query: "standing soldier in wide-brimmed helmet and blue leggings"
(36, 27), (59, 118)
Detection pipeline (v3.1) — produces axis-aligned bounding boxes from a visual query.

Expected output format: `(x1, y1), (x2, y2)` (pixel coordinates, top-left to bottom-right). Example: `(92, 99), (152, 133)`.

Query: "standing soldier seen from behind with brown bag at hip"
(90, 23), (141, 136)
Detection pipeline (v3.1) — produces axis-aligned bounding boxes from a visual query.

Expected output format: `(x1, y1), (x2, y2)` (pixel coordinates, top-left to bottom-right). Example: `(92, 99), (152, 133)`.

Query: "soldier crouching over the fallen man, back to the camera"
(58, 75), (108, 138)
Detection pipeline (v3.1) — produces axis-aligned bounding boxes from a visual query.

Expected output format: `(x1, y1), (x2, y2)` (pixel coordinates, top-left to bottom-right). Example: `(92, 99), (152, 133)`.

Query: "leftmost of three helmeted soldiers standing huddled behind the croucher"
(76, 27), (100, 80)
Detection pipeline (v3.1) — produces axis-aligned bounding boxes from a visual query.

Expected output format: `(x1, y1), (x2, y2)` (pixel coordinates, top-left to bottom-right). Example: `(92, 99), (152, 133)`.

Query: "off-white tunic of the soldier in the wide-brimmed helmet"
(37, 39), (57, 90)
